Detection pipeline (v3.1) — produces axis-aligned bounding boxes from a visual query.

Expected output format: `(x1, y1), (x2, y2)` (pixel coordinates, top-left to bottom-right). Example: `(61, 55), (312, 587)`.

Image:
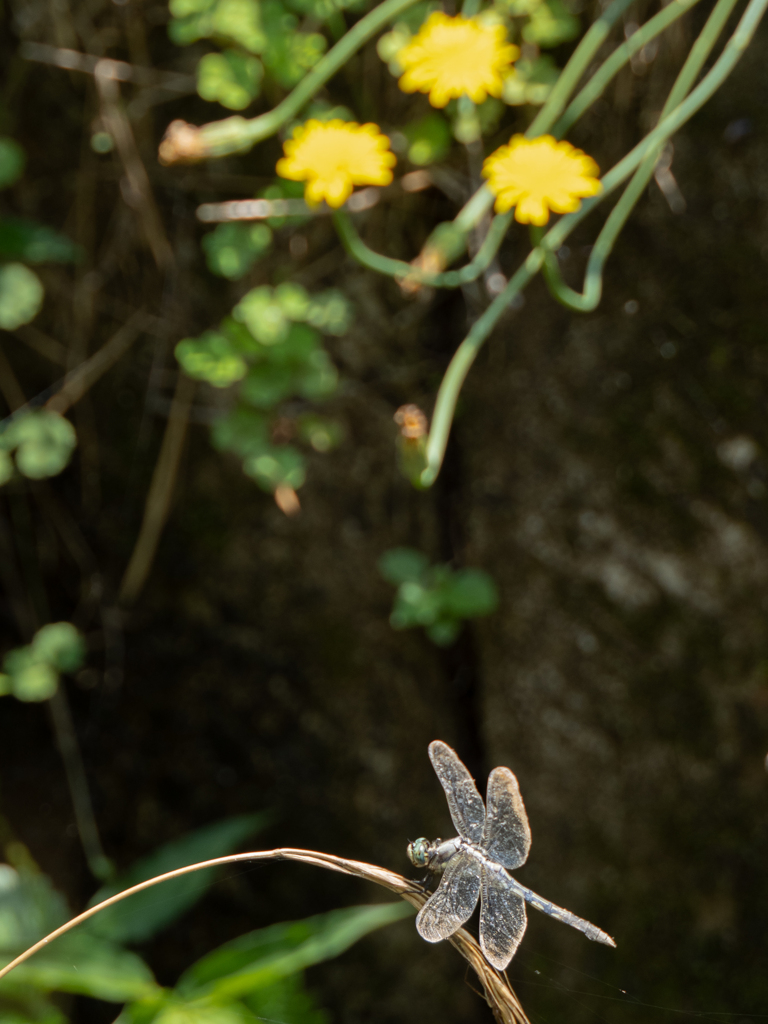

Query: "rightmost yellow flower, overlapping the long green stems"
(482, 135), (602, 226)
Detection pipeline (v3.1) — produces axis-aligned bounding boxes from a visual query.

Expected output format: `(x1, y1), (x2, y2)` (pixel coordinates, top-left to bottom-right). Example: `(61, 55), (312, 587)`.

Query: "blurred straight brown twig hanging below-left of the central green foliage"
(119, 374), (196, 604)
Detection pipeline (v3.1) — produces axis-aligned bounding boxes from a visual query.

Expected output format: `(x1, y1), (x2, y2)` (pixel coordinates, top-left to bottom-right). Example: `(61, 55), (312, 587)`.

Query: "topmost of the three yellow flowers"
(396, 11), (520, 106)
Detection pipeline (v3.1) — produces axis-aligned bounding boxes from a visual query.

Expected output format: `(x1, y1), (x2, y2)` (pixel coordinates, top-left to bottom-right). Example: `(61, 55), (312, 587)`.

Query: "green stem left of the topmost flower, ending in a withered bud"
(192, 0), (416, 157)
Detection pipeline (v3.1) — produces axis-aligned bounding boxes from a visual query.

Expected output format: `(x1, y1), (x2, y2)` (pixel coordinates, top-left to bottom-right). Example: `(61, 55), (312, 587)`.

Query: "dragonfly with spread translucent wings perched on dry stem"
(408, 739), (615, 971)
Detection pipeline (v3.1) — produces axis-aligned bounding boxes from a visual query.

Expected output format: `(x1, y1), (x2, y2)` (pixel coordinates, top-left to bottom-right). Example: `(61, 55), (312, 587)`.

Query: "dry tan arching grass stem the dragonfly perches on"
(0, 847), (530, 1024)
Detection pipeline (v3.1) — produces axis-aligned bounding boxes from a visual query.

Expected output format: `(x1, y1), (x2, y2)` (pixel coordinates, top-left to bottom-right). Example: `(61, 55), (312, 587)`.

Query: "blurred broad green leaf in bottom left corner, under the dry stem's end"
(0, 929), (158, 1002)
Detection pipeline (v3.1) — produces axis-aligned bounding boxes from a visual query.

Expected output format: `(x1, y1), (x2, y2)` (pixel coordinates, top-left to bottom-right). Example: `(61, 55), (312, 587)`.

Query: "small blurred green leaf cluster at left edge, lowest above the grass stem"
(0, 623), (85, 700)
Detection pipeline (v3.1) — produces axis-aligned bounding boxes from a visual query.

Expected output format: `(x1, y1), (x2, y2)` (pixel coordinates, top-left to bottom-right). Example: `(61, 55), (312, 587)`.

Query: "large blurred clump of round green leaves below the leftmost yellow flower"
(176, 284), (351, 492)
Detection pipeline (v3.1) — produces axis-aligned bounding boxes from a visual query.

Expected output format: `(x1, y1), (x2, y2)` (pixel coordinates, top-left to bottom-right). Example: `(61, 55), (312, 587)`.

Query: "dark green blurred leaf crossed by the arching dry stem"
(87, 814), (267, 942)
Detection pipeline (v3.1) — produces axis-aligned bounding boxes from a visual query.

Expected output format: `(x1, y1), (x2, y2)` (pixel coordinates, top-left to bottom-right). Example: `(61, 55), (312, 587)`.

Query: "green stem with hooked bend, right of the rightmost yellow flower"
(531, 0), (736, 312)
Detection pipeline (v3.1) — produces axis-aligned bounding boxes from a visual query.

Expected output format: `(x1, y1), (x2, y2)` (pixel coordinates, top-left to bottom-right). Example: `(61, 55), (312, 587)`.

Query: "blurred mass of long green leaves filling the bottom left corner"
(0, 814), (413, 1024)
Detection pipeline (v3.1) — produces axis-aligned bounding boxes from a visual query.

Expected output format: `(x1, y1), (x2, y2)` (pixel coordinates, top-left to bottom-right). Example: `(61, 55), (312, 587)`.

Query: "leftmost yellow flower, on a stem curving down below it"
(275, 119), (397, 207)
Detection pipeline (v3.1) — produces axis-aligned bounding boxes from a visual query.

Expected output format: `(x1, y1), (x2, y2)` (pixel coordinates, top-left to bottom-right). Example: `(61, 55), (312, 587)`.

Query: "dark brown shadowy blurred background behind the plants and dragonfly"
(0, 0), (768, 1024)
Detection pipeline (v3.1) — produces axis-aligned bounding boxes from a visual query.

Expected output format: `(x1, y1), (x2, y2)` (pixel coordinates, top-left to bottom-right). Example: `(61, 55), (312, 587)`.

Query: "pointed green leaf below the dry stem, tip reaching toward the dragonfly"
(177, 901), (414, 999)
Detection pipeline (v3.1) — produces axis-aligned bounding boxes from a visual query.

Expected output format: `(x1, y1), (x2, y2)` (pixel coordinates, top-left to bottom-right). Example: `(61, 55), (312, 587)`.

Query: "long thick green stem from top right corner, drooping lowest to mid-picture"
(421, 0), (768, 487)
